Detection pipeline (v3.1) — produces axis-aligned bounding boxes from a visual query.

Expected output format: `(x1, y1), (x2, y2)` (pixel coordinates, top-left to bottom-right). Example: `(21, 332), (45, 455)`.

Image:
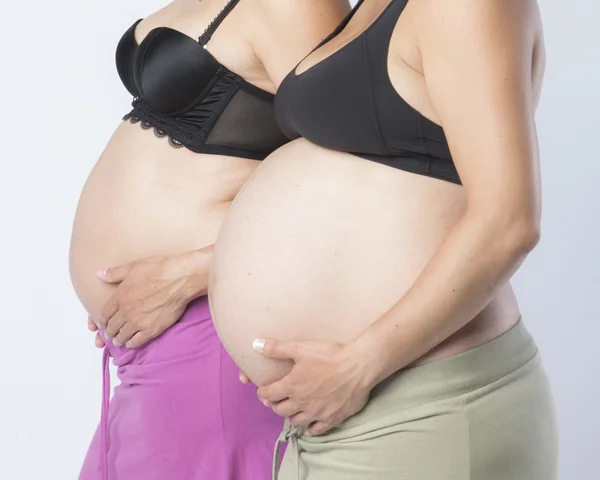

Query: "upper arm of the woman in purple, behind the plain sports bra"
(251, 0), (350, 89)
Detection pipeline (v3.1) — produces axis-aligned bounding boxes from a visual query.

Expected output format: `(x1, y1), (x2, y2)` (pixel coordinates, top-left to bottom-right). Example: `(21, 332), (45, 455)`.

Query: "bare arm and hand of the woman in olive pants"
(223, 0), (544, 435)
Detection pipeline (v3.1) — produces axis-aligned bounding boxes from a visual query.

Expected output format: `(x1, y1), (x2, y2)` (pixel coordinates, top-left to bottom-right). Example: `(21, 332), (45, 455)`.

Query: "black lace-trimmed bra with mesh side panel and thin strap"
(116, 0), (288, 160)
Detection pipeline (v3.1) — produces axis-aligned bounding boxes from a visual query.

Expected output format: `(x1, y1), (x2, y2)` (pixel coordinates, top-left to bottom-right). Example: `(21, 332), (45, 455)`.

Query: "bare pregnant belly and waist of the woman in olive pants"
(209, 139), (519, 384)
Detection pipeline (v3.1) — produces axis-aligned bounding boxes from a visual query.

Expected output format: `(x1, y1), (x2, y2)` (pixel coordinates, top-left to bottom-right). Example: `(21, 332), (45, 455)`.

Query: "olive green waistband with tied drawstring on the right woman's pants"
(272, 320), (537, 480)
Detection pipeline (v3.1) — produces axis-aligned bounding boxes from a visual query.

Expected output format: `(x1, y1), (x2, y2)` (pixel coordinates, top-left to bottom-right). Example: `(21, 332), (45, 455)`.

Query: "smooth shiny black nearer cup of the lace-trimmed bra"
(133, 27), (221, 115)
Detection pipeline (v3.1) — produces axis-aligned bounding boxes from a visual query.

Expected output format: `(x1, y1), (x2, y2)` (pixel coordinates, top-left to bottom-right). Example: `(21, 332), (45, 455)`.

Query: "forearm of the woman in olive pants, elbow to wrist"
(350, 208), (537, 385)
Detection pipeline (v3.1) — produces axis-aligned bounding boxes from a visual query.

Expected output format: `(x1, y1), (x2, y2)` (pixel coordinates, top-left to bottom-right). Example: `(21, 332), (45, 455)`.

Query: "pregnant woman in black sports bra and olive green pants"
(209, 0), (557, 480)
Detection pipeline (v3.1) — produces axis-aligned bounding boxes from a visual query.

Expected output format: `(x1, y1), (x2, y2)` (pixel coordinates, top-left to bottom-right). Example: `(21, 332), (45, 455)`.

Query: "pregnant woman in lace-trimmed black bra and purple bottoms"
(70, 0), (348, 480)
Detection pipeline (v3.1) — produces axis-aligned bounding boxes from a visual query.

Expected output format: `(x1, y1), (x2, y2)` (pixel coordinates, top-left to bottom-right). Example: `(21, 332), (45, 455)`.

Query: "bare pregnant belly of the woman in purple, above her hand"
(70, 123), (259, 314)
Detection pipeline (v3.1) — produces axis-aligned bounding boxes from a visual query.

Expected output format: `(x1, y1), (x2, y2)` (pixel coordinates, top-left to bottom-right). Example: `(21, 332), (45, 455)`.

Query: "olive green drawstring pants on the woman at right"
(273, 321), (558, 480)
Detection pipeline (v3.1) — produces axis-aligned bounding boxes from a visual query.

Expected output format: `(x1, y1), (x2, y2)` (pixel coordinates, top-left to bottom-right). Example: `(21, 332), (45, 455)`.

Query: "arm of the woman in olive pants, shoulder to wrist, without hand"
(349, 0), (541, 385)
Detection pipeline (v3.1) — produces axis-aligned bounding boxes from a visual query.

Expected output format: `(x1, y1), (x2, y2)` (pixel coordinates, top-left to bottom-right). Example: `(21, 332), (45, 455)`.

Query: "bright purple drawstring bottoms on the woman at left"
(79, 297), (283, 480)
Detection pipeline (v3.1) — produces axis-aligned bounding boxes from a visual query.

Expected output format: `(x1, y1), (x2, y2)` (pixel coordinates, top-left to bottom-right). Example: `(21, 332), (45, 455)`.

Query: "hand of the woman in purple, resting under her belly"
(97, 252), (210, 348)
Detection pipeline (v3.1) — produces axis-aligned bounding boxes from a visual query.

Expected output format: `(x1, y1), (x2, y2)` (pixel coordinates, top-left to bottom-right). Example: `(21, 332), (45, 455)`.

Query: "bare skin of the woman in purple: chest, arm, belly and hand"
(77, 0), (350, 348)
